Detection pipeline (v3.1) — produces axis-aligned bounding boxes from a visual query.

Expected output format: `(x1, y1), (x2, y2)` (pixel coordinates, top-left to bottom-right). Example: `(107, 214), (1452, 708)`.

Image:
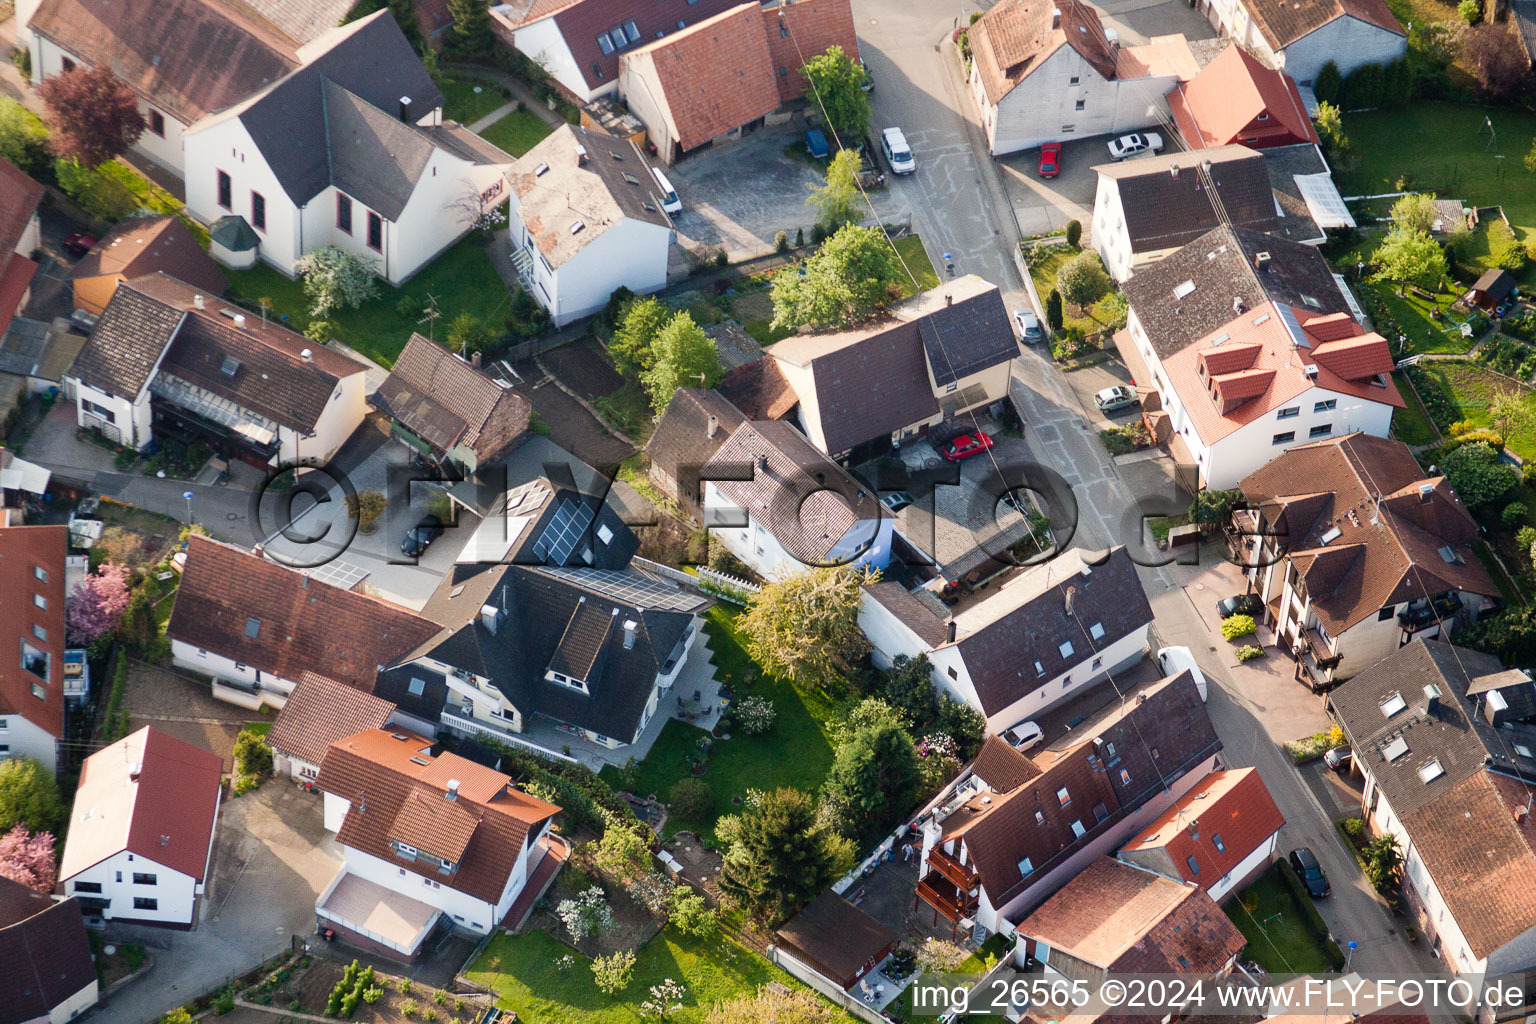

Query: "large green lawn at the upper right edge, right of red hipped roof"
(1336, 102), (1536, 260)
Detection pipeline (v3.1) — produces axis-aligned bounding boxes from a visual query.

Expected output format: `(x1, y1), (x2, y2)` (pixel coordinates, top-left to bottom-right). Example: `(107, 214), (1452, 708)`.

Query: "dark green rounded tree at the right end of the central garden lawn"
(822, 725), (919, 840)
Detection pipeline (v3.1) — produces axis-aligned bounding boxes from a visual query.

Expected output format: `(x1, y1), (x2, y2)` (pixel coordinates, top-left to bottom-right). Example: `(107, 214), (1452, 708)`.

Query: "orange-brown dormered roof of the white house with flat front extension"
(315, 729), (559, 903)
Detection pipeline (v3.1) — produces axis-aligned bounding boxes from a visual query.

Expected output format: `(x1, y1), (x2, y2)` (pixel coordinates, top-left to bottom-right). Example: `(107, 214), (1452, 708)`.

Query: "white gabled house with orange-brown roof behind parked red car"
(968, 0), (1200, 155)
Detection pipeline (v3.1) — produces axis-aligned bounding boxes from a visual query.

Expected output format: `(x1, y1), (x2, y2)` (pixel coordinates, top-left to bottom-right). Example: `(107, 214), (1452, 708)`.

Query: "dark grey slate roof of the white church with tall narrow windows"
(240, 11), (442, 220)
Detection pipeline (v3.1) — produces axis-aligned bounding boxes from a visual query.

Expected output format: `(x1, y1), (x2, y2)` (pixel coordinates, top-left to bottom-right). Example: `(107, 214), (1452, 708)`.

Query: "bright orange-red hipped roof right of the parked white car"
(1167, 46), (1319, 149)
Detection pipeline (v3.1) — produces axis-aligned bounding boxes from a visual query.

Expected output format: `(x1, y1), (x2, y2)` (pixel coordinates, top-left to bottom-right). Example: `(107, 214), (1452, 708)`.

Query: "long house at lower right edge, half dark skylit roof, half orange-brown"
(1329, 640), (1536, 978)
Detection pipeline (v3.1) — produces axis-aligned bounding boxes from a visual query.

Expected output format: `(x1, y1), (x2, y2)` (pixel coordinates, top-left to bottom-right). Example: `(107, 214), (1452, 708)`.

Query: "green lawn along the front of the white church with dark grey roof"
(224, 238), (511, 367)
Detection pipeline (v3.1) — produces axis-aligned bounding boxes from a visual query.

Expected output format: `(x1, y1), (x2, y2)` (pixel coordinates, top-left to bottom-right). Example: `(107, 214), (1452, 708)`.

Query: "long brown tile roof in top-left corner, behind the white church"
(28, 0), (298, 124)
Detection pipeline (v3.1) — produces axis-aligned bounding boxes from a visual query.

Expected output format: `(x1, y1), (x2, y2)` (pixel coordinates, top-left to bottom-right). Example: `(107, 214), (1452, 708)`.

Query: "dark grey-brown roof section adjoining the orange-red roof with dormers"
(1123, 227), (1349, 358)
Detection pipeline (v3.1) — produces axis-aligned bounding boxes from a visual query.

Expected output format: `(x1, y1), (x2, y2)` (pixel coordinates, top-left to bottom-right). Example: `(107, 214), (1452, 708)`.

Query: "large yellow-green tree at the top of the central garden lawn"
(737, 565), (871, 686)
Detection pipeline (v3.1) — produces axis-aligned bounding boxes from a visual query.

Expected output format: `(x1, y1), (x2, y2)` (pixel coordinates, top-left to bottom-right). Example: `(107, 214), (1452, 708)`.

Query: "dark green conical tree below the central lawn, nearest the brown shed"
(714, 788), (854, 924)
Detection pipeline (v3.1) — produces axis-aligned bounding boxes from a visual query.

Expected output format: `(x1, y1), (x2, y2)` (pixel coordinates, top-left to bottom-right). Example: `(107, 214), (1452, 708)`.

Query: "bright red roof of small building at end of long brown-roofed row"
(1120, 768), (1286, 886)
